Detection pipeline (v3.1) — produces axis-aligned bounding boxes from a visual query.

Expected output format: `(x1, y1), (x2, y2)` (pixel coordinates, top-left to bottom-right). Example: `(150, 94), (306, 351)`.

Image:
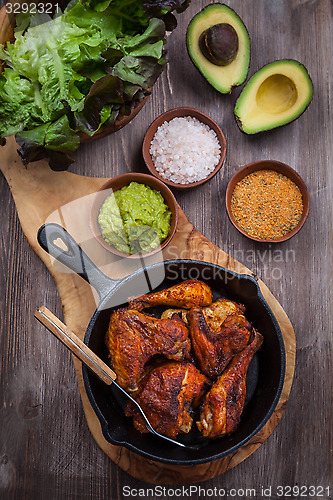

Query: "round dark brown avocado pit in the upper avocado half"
(199, 23), (239, 66)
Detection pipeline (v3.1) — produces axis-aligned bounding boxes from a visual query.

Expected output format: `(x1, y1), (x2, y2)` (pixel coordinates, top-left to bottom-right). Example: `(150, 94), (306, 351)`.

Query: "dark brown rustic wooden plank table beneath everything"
(0, 0), (333, 500)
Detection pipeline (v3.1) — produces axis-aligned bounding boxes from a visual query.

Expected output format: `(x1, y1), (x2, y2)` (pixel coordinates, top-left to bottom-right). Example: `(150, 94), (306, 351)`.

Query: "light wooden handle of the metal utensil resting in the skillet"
(34, 306), (117, 385)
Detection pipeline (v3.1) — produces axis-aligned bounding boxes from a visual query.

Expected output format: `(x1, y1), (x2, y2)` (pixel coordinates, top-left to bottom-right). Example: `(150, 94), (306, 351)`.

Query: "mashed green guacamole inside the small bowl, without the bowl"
(98, 182), (171, 255)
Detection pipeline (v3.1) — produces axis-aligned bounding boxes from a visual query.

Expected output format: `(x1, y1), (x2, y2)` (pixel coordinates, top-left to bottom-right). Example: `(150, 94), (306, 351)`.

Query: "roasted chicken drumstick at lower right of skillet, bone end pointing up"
(197, 331), (263, 439)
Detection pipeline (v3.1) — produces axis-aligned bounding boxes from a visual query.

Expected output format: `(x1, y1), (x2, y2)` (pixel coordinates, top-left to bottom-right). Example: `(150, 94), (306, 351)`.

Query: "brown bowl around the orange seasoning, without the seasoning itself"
(225, 160), (310, 243)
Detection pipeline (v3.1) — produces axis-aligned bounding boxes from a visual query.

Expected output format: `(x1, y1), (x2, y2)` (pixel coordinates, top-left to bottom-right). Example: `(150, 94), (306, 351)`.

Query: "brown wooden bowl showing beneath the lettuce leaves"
(0, 0), (151, 143)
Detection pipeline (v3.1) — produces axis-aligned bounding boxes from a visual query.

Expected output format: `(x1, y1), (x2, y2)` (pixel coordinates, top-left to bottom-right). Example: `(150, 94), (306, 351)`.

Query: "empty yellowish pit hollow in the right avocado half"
(256, 74), (297, 114)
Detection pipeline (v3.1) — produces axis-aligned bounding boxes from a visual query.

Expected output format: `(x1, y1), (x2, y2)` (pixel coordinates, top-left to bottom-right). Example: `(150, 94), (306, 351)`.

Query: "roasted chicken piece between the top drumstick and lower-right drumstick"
(187, 307), (251, 379)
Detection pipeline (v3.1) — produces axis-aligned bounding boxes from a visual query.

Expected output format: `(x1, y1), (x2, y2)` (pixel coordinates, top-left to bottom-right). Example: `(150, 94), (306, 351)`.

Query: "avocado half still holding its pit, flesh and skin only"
(186, 3), (250, 94)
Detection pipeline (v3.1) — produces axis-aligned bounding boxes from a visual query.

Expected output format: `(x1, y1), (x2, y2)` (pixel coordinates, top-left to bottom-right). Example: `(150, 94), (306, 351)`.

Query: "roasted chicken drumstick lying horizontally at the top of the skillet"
(129, 280), (212, 311)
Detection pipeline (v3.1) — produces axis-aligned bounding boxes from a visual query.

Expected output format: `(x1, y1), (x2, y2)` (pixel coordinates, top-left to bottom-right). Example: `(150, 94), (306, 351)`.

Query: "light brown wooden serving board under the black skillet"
(0, 138), (296, 484)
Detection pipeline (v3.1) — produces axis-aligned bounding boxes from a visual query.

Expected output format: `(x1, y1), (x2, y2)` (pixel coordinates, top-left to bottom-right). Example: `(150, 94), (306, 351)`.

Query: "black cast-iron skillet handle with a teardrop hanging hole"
(37, 222), (117, 299)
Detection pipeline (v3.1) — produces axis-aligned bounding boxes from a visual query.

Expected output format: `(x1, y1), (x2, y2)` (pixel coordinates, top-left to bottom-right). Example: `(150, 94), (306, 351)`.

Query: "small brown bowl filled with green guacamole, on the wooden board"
(91, 173), (178, 258)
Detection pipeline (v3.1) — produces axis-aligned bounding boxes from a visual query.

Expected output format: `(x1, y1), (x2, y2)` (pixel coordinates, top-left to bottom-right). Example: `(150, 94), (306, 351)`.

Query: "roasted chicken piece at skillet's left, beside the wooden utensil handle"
(105, 308), (191, 391)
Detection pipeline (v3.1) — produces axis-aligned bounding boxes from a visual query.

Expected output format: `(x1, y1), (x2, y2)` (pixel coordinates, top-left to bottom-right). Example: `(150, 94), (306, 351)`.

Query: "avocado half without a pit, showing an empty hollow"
(235, 59), (313, 134)
